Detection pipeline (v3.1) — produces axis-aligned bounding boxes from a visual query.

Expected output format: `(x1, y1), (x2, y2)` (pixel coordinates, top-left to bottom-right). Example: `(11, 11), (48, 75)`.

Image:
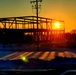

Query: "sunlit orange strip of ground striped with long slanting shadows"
(0, 51), (76, 61)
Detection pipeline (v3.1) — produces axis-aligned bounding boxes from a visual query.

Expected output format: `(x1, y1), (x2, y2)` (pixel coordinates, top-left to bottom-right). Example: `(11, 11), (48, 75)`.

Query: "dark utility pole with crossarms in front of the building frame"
(30, 0), (42, 50)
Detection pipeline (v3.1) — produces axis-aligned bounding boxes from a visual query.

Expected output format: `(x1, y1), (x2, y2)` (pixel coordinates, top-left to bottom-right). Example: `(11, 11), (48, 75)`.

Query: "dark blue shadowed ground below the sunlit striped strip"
(0, 57), (76, 75)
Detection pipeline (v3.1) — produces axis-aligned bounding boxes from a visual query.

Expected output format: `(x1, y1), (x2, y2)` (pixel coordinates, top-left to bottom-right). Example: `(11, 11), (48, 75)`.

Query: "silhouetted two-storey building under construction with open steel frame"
(0, 16), (65, 43)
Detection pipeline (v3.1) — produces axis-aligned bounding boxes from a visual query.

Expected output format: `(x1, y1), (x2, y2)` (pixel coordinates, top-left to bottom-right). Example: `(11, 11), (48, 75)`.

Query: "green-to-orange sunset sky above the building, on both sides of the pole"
(0, 0), (76, 32)
